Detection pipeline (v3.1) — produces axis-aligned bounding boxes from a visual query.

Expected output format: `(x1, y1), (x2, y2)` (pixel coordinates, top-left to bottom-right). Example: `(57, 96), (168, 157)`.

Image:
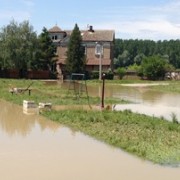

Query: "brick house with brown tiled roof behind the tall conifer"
(49, 26), (115, 78)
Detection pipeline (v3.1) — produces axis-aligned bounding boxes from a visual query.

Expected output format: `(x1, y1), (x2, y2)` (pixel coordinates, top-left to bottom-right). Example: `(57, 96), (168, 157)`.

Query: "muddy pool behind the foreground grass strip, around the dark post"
(86, 84), (180, 122)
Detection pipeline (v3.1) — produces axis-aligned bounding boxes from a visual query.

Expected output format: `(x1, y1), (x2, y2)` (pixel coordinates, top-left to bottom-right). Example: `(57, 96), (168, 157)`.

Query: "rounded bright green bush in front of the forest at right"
(140, 56), (167, 80)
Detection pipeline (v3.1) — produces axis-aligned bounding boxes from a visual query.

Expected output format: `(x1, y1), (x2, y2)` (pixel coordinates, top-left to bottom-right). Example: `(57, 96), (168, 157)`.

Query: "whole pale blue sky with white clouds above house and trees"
(0, 0), (180, 41)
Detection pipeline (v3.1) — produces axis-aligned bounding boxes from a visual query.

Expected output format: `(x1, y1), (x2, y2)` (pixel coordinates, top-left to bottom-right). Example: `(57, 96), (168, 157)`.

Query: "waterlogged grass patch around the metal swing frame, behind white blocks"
(0, 79), (128, 105)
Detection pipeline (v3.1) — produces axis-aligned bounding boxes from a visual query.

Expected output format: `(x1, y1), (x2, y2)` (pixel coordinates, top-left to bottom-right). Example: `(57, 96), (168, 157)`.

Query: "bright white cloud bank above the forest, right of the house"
(91, 0), (180, 40)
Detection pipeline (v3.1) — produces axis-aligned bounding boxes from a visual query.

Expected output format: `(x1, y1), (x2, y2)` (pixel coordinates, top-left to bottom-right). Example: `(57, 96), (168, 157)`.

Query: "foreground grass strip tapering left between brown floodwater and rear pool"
(44, 110), (180, 165)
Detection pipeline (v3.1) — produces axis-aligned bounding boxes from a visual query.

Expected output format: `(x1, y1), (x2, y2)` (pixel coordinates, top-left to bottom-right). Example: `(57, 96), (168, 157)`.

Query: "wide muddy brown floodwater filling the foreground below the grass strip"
(0, 101), (180, 180)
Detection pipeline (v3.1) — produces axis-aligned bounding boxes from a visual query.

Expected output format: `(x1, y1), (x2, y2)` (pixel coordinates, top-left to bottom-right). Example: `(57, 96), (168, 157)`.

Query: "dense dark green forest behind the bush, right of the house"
(114, 39), (180, 69)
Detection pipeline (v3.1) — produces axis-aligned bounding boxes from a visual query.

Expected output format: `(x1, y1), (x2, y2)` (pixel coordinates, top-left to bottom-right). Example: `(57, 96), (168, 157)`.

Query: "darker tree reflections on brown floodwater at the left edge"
(0, 101), (59, 136)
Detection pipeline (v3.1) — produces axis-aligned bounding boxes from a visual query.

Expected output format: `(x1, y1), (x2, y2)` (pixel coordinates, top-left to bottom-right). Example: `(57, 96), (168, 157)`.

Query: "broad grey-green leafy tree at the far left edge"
(0, 20), (37, 70)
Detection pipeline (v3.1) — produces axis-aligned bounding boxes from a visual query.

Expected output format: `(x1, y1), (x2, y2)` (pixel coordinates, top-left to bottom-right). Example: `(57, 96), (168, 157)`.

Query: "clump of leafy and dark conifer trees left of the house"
(0, 20), (56, 77)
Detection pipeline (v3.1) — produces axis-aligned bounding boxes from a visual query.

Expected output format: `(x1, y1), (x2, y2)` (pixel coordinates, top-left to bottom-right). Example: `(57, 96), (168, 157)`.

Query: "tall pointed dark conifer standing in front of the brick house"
(66, 24), (86, 74)
